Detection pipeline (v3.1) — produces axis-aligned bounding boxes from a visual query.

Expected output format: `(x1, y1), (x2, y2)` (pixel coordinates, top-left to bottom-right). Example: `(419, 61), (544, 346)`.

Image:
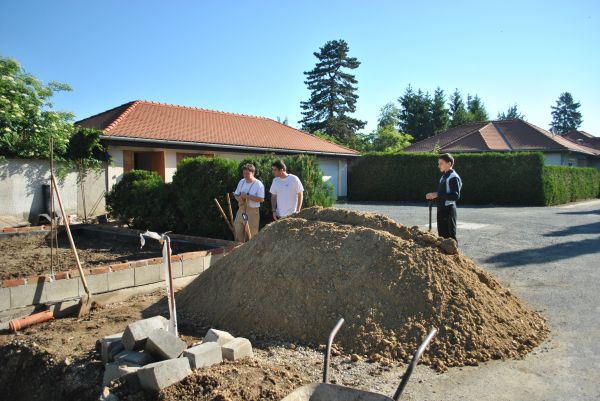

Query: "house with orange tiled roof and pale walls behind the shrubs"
(76, 100), (359, 197)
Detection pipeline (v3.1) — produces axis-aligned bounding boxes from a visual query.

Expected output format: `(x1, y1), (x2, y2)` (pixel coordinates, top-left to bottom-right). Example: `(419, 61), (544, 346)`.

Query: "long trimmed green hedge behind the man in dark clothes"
(348, 153), (598, 205)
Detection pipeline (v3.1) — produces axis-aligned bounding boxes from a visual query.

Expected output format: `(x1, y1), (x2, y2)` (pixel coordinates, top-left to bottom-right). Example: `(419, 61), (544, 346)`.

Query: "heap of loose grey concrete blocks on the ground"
(100, 316), (253, 392)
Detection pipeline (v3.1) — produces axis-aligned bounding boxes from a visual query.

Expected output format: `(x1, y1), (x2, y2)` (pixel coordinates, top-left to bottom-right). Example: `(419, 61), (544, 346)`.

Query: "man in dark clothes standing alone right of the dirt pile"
(425, 153), (462, 242)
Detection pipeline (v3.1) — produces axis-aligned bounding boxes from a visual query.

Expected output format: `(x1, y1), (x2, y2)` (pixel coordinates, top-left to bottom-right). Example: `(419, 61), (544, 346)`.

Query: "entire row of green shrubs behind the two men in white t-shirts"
(106, 155), (335, 239)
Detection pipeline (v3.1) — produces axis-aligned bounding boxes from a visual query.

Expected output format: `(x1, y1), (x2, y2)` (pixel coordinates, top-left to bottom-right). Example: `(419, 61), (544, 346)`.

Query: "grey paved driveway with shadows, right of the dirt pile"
(337, 200), (600, 401)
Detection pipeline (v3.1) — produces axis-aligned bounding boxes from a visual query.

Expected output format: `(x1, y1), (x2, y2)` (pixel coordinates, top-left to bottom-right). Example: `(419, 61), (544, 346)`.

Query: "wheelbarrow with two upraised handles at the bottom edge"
(281, 319), (437, 401)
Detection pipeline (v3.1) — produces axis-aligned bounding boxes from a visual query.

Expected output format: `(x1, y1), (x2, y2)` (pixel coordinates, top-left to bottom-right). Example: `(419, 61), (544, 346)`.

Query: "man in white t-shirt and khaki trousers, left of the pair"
(233, 164), (265, 242)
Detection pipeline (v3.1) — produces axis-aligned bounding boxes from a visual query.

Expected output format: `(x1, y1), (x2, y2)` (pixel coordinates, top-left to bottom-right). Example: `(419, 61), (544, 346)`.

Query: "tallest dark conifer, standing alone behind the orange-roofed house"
(299, 40), (366, 143)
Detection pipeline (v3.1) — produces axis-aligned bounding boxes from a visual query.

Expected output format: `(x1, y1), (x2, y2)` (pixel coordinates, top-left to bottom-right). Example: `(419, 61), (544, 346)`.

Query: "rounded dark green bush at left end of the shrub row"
(106, 170), (174, 231)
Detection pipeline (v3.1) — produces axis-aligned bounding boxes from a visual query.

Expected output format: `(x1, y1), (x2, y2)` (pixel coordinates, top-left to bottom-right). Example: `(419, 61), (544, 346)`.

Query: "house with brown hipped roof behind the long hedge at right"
(404, 120), (600, 169)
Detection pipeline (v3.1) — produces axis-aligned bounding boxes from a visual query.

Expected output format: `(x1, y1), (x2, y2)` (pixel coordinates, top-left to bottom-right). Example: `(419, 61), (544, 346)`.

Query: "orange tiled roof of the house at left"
(77, 100), (358, 156)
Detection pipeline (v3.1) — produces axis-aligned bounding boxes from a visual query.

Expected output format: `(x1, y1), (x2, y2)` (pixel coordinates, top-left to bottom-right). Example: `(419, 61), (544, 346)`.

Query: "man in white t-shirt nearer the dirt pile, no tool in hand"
(269, 160), (304, 220)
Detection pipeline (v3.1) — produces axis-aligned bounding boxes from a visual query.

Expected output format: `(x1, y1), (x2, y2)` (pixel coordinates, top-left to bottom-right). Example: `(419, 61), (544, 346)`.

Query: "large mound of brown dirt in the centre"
(178, 208), (548, 370)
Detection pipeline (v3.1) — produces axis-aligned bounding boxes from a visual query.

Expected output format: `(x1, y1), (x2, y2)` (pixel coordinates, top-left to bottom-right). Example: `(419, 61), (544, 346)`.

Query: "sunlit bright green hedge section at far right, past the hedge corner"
(543, 166), (600, 205)
